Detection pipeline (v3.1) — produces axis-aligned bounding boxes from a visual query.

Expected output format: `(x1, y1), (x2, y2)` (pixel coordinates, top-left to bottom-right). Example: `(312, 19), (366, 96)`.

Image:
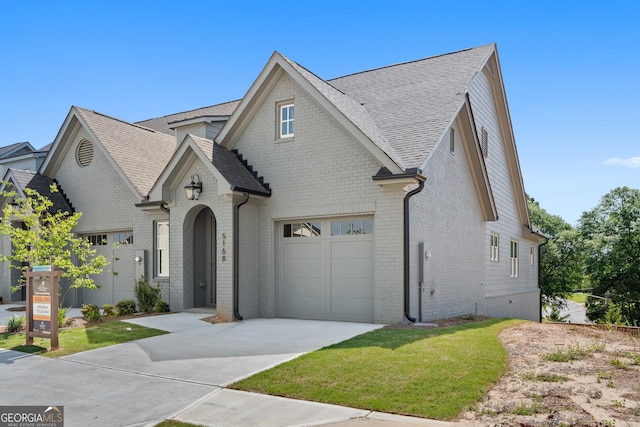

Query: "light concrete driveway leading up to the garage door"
(0, 313), (381, 427)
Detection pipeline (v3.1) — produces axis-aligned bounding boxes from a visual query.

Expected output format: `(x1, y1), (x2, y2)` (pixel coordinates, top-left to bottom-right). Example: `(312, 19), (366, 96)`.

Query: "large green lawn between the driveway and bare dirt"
(232, 319), (521, 420)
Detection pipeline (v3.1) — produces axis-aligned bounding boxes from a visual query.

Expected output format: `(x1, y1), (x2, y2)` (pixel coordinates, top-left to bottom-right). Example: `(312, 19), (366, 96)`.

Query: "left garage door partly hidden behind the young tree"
(83, 232), (136, 307)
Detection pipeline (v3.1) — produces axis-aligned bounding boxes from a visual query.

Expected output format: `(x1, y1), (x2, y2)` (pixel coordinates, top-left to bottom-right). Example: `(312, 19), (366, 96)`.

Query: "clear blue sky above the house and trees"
(0, 0), (640, 224)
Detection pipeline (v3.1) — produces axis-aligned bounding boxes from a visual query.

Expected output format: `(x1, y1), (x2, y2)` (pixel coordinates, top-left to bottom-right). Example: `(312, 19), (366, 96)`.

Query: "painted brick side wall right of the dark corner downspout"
(411, 120), (485, 320)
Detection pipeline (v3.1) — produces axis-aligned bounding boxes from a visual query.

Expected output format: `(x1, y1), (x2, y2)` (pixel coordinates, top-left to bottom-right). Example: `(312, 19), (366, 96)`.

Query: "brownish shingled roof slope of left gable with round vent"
(74, 107), (176, 196)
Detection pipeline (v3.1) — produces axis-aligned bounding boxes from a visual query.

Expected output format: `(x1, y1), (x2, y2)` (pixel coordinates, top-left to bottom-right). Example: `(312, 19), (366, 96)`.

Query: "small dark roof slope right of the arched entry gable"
(189, 135), (271, 196)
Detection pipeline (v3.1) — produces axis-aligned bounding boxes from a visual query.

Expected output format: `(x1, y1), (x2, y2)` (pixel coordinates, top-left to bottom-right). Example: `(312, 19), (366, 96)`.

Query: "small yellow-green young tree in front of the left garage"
(0, 183), (108, 300)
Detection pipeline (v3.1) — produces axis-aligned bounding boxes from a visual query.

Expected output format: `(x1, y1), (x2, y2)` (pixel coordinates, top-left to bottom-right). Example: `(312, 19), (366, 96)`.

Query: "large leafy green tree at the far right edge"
(579, 187), (640, 324)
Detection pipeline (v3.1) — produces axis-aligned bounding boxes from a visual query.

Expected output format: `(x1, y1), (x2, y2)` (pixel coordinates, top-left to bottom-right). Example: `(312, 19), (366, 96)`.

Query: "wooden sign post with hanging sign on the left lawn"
(24, 265), (62, 350)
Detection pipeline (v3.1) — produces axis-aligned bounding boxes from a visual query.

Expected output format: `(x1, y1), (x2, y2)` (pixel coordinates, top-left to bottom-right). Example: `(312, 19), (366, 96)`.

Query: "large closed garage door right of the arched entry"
(279, 217), (373, 322)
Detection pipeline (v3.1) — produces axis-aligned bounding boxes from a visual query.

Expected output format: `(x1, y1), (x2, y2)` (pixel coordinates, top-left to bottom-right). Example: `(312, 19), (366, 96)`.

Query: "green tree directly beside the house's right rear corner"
(527, 196), (584, 310)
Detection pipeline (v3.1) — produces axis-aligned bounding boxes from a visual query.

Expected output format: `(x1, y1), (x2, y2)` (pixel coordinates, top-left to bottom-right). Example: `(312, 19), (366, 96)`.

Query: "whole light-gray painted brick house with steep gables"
(0, 44), (542, 323)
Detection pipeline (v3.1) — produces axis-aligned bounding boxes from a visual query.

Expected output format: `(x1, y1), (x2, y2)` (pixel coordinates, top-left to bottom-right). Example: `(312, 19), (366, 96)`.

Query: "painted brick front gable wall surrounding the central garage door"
(232, 75), (404, 323)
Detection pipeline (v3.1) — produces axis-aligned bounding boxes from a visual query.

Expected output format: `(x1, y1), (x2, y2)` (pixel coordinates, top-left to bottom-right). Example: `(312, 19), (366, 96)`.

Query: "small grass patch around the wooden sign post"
(0, 321), (167, 357)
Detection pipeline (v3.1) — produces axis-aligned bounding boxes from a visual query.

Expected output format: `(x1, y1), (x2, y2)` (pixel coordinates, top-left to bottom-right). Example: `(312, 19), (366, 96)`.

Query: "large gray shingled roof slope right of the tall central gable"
(321, 44), (495, 170)
